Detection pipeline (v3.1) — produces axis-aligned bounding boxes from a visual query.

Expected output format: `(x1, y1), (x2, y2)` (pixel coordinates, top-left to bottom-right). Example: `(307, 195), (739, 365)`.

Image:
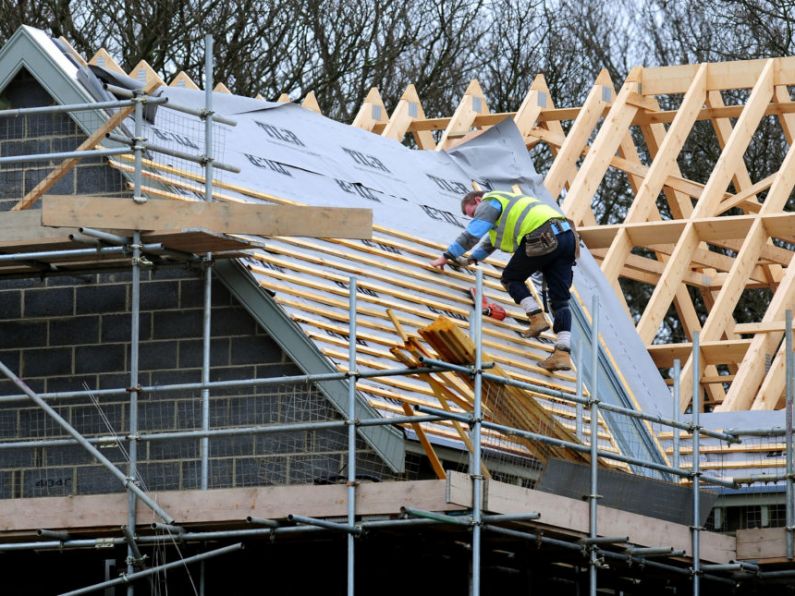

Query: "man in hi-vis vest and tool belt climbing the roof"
(430, 191), (578, 371)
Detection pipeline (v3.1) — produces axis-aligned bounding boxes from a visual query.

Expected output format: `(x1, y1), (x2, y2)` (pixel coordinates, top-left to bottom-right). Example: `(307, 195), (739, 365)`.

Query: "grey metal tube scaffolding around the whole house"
(0, 36), (795, 596)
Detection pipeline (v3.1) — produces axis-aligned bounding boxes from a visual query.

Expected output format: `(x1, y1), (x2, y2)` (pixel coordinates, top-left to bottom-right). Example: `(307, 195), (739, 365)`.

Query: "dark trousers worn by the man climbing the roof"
(500, 230), (576, 333)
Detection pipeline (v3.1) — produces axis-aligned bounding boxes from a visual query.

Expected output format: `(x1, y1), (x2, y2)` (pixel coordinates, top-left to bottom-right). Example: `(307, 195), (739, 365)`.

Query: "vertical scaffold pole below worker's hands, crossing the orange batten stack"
(469, 268), (483, 596)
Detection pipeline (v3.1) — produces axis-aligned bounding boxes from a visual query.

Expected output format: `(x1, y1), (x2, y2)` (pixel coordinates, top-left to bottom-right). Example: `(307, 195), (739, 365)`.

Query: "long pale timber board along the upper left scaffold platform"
(41, 195), (372, 238)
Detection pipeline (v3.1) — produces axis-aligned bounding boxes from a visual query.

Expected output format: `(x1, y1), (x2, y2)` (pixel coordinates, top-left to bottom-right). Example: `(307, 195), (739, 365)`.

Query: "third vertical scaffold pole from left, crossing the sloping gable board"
(347, 277), (358, 596)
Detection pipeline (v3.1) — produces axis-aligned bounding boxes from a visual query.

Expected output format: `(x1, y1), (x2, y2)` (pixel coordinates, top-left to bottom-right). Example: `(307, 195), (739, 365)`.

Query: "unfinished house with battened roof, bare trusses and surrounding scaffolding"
(0, 27), (795, 596)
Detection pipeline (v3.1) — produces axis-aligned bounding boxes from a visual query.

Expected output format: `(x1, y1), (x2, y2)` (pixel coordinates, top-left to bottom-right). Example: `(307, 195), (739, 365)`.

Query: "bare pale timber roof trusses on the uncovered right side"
(338, 58), (795, 411)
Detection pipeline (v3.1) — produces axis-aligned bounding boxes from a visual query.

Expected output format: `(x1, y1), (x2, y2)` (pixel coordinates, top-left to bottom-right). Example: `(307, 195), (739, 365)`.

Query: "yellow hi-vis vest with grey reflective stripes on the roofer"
(483, 190), (563, 253)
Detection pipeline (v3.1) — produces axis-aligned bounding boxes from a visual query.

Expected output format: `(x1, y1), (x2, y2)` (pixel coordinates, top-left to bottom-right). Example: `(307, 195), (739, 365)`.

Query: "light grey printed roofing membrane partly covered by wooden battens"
(105, 88), (670, 466)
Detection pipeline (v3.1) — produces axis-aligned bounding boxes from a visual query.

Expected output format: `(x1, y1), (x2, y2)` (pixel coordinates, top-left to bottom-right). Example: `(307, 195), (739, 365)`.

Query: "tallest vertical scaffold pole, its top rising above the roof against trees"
(199, 35), (213, 596)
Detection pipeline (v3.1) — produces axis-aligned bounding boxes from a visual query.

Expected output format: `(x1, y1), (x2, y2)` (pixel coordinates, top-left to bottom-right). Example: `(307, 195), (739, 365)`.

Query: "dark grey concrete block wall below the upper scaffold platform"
(0, 267), (398, 498)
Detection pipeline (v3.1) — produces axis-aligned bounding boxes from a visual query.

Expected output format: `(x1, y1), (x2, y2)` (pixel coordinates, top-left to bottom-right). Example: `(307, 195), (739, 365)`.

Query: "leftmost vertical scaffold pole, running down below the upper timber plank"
(127, 229), (141, 596)
